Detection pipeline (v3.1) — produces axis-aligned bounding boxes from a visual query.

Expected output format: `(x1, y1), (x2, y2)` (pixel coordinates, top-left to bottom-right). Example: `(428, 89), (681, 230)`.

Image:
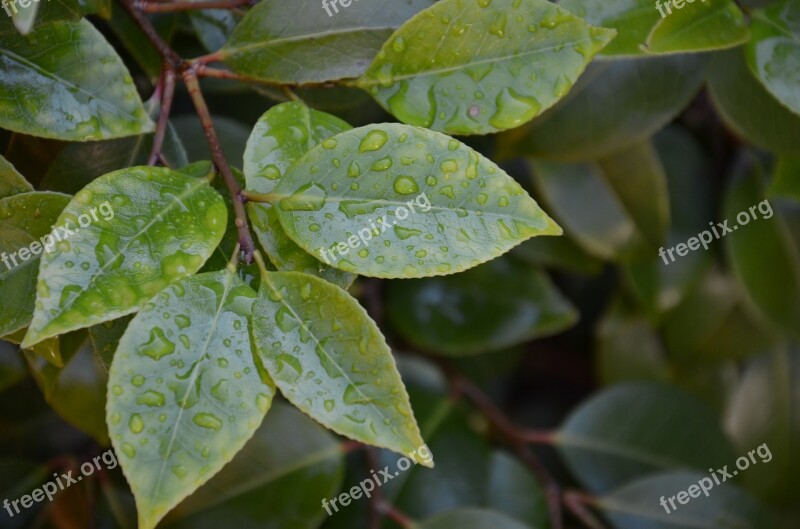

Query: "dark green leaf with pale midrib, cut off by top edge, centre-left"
(221, 0), (433, 84)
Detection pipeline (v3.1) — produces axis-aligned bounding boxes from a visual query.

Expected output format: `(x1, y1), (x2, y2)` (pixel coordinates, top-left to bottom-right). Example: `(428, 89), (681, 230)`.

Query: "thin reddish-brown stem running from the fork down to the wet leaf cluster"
(181, 68), (256, 264)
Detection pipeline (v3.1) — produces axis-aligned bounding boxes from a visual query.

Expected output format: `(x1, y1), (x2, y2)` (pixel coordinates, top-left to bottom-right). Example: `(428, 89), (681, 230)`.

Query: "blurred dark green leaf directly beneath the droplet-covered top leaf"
(500, 55), (707, 161)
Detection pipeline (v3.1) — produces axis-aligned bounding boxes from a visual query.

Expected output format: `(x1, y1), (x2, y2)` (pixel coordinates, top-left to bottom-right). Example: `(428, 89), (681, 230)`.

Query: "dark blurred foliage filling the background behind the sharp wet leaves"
(0, 0), (800, 529)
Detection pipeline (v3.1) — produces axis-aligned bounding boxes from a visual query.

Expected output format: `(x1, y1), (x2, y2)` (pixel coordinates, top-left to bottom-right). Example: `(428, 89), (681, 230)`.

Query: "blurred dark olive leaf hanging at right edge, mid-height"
(723, 156), (800, 337)
